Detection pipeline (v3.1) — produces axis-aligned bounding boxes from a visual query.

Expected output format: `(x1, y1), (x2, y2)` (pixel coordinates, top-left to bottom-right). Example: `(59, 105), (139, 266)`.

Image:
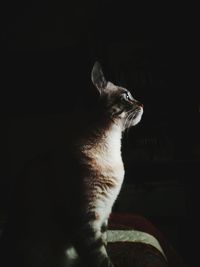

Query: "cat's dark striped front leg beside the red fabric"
(73, 222), (113, 267)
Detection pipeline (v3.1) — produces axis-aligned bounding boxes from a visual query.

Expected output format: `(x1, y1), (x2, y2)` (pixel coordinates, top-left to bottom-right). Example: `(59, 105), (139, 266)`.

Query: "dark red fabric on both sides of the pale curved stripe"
(109, 213), (185, 267)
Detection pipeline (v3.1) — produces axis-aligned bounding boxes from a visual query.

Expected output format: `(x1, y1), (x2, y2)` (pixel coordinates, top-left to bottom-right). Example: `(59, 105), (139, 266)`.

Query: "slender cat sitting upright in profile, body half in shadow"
(0, 62), (143, 267)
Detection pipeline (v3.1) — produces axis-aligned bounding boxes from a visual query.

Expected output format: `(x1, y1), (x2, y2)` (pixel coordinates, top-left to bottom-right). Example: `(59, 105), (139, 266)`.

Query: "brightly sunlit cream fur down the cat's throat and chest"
(84, 124), (124, 225)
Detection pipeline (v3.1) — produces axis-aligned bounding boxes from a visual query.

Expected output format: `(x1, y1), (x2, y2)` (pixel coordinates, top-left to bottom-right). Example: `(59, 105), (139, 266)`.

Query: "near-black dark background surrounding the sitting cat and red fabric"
(0, 0), (200, 263)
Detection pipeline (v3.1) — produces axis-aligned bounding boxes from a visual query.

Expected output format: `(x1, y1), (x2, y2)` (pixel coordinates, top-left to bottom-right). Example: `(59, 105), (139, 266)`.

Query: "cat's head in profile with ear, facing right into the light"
(91, 62), (143, 130)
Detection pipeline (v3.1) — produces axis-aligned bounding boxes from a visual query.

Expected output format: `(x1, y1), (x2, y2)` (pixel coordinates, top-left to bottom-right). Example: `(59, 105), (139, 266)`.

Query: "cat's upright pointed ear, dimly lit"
(91, 61), (107, 93)
